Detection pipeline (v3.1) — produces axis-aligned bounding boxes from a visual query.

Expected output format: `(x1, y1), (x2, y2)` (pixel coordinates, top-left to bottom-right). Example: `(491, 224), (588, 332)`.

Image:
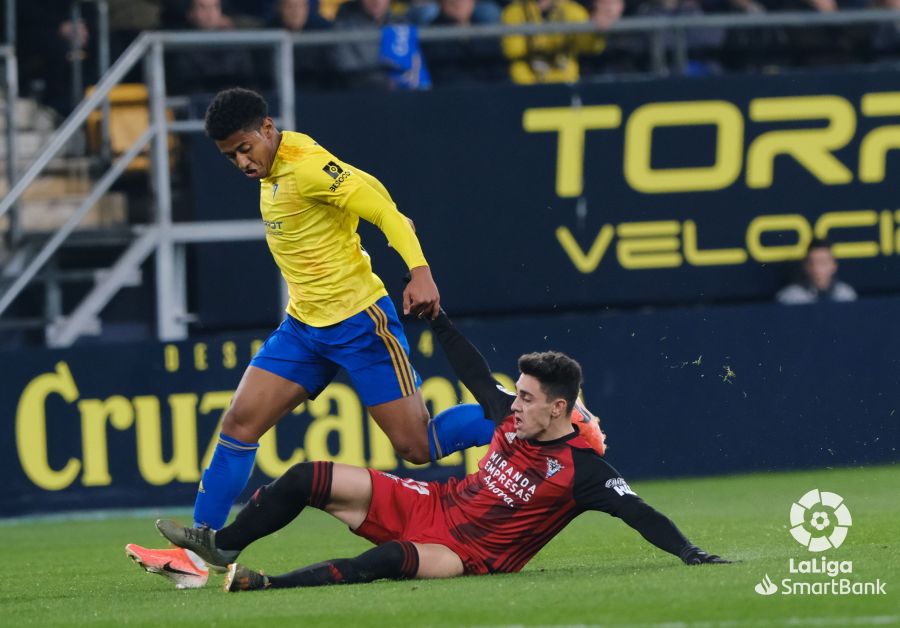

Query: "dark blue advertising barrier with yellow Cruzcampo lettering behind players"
(0, 299), (900, 516)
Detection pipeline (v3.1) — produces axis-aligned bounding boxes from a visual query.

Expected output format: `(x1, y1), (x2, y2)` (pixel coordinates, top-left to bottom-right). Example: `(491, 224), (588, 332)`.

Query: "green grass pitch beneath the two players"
(0, 465), (900, 627)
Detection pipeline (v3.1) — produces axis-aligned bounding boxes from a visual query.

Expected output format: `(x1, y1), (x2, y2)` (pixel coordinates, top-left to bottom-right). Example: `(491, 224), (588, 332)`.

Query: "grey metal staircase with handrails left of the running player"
(0, 31), (294, 347)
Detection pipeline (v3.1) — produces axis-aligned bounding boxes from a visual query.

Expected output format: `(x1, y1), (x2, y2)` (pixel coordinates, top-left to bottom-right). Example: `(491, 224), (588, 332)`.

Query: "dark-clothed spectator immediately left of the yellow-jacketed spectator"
(422, 0), (506, 87)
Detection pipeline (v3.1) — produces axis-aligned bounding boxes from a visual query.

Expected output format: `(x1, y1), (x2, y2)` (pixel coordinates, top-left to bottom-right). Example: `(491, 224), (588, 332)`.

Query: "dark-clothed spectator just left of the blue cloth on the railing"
(332, 0), (397, 88)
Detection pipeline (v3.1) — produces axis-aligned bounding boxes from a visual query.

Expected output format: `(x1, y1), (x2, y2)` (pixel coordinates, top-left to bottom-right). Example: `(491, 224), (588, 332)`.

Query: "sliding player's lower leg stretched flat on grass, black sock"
(225, 541), (464, 591)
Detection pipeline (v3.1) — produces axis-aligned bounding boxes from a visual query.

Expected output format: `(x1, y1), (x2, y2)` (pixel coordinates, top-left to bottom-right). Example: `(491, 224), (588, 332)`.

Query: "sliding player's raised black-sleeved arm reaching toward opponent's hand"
(431, 310), (515, 423)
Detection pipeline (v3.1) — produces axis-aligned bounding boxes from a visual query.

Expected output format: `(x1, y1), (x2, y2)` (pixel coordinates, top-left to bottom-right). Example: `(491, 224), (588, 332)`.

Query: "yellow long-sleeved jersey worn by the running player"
(259, 131), (427, 327)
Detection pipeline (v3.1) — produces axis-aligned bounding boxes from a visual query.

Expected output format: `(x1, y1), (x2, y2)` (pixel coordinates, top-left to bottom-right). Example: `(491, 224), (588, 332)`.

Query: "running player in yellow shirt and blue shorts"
(126, 88), (493, 587)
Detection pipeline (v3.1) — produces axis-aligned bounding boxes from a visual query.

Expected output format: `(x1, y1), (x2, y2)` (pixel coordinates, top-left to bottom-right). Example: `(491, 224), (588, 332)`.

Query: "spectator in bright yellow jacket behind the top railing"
(501, 0), (606, 85)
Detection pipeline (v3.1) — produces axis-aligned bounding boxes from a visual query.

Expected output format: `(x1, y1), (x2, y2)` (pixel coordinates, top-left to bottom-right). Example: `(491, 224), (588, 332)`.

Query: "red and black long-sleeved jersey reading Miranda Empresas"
(432, 312), (693, 572)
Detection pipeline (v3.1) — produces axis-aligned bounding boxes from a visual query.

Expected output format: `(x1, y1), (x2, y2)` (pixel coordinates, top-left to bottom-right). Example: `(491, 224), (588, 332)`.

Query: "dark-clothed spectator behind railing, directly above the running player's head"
(170, 0), (258, 94)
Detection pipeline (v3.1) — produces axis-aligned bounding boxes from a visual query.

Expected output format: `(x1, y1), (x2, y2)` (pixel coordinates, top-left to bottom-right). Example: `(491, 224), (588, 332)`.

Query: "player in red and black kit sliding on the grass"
(158, 312), (729, 591)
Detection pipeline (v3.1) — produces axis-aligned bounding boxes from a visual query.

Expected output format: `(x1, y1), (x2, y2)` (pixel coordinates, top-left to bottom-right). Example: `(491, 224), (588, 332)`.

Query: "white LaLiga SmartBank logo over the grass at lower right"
(753, 489), (886, 595)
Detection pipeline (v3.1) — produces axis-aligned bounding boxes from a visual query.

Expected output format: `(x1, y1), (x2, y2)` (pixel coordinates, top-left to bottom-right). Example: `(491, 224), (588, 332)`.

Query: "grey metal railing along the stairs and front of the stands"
(0, 6), (900, 346)
